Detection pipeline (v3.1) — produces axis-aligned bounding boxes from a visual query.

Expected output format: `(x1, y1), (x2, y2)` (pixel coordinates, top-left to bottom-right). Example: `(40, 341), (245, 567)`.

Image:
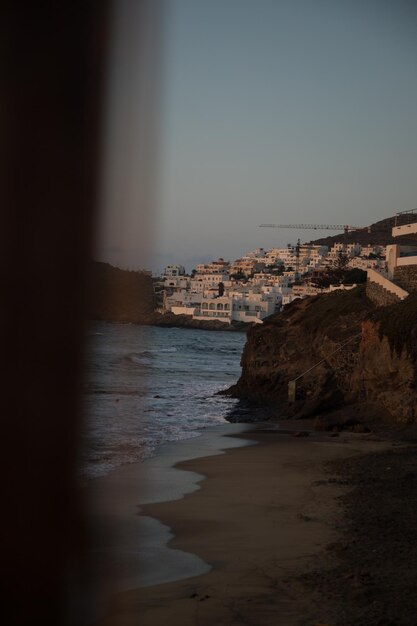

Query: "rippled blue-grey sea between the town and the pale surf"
(83, 322), (246, 477)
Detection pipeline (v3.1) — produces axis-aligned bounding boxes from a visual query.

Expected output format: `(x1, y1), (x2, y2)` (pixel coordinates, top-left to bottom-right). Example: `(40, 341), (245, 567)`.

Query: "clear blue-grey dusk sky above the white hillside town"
(96, 0), (417, 271)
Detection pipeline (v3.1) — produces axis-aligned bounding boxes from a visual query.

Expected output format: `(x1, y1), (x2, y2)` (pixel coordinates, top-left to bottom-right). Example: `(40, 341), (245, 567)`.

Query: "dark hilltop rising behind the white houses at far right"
(308, 215), (417, 248)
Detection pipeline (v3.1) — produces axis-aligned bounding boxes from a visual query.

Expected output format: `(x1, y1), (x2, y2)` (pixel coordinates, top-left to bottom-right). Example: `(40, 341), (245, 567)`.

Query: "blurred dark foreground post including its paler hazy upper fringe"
(0, 0), (163, 626)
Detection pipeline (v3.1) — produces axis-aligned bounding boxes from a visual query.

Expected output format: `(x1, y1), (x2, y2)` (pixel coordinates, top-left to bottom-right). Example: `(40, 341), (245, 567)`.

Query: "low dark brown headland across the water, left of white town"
(88, 261), (155, 324)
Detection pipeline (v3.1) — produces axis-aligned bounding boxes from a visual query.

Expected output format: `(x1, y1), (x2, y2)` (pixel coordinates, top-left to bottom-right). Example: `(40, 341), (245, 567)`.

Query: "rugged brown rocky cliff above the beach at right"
(229, 286), (417, 421)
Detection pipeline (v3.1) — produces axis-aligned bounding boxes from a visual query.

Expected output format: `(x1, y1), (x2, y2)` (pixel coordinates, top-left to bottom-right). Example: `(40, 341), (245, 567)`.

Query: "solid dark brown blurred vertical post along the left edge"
(0, 0), (109, 626)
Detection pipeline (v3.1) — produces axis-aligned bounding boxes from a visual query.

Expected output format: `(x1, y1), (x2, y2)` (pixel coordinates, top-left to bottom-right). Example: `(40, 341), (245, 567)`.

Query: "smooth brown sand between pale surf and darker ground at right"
(89, 423), (398, 626)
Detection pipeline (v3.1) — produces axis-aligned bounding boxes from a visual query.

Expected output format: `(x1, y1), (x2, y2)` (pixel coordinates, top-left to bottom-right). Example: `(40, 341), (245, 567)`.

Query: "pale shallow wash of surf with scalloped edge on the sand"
(84, 423), (254, 615)
